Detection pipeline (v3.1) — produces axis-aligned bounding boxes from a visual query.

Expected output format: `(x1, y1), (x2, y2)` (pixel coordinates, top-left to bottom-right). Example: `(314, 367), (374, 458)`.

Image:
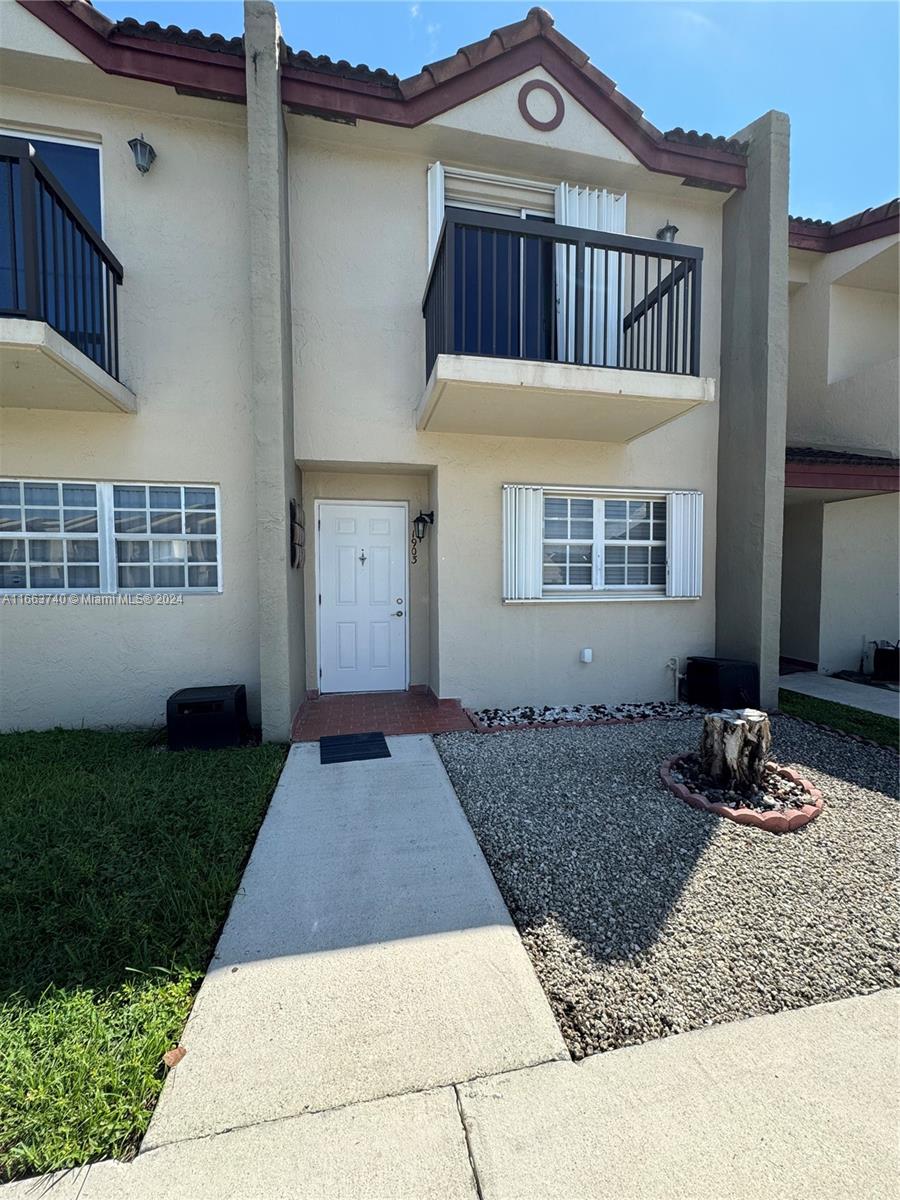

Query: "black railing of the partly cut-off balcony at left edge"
(0, 137), (122, 379)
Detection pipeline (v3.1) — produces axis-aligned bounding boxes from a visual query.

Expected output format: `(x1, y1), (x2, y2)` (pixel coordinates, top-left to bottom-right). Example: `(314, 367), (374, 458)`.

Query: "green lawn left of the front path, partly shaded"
(0, 730), (286, 1181)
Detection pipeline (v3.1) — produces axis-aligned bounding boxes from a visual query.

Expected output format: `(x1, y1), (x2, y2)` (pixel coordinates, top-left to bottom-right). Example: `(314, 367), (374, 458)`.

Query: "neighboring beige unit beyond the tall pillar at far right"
(781, 200), (900, 673)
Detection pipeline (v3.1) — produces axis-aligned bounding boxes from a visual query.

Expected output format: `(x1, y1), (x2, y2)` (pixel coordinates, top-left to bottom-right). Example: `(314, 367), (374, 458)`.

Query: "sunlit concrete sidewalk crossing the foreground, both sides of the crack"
(8, 991), (900, 1200)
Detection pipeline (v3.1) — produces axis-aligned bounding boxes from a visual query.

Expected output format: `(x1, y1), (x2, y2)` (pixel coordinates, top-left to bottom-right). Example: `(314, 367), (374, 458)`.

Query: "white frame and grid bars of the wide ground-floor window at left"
(0, 475), (223, 596)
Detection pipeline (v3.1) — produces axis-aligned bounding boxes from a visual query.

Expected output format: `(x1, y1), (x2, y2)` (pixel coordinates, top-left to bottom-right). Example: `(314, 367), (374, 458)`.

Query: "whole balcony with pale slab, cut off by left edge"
(0, 138), (136, 412)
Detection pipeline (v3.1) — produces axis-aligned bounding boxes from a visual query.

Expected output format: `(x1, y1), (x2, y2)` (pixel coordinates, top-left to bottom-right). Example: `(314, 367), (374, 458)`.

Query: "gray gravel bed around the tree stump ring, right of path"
(434, 716), (900, 1058)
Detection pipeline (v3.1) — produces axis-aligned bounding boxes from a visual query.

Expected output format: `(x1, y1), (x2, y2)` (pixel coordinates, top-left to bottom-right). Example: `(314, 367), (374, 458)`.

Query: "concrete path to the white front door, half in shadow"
(143, 737), (568, 1150)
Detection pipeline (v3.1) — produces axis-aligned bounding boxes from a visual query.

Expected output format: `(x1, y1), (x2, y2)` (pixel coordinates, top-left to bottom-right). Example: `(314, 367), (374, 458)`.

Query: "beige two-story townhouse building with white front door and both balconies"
(0, 0), (895, 738)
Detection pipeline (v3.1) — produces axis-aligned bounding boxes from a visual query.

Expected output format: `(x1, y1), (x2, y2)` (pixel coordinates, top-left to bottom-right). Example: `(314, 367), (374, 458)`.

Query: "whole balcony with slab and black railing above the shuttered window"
(416, 209), (715, 443)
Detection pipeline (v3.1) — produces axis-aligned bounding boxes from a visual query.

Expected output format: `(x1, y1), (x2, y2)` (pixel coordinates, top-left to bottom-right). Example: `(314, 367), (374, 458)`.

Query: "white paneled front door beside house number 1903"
(317, 500), (408, 692)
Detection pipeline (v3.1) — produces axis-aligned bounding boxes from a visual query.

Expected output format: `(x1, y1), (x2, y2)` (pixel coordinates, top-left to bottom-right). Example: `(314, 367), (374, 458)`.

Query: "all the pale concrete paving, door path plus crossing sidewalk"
(0, 737), (900, 1200)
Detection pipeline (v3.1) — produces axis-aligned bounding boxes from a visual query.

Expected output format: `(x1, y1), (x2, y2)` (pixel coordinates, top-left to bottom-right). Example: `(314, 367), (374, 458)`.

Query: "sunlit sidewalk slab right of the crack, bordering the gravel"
(458, 991), (900, 1200)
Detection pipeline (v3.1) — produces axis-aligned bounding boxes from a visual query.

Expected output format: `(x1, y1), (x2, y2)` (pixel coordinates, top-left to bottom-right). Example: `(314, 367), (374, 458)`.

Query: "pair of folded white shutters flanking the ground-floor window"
(503, 484), (703, 600)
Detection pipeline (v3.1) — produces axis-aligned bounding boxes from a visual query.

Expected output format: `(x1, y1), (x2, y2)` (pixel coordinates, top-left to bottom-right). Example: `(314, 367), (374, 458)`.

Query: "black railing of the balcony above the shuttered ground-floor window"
(422, 209), (703, 379)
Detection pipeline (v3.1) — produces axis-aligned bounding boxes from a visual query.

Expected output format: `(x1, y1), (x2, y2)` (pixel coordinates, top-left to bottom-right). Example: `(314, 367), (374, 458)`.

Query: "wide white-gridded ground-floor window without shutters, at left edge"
(0, 480), (221, 593)
